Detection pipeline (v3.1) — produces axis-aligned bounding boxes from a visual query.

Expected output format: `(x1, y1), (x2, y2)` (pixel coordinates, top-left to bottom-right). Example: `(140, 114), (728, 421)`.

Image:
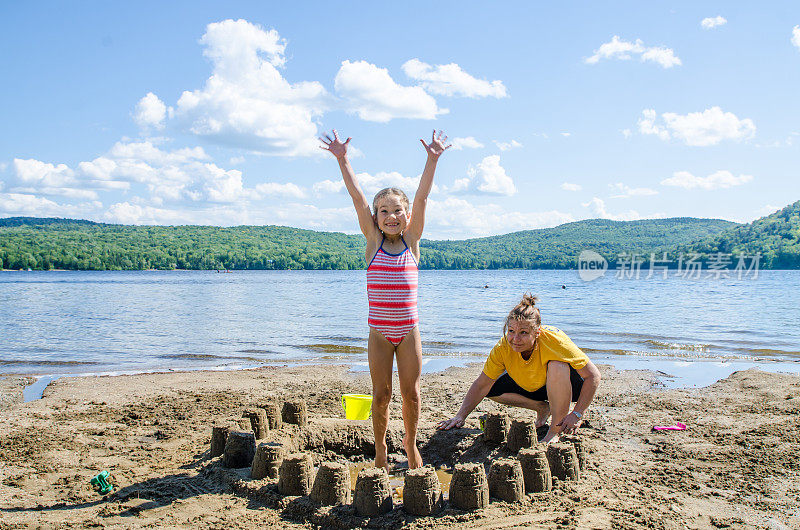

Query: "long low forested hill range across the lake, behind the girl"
(0, 213), (738, 270)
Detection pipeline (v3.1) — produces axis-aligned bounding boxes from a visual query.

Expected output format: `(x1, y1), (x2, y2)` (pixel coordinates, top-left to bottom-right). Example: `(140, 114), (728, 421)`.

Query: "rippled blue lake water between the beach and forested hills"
(0, 270), (800, 392)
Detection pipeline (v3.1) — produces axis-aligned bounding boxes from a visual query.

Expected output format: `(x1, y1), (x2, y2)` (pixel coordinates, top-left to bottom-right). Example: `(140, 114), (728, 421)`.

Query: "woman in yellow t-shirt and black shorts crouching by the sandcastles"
(438, 294), (600, 443)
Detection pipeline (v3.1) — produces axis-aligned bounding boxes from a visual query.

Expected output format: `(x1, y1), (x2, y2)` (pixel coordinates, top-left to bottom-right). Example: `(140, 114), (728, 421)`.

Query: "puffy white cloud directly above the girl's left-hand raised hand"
(334, 61), (448, 122)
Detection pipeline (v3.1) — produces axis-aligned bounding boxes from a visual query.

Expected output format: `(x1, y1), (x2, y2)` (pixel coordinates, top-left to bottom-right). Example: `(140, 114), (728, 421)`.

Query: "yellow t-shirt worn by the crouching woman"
(483, 326), (589, 392)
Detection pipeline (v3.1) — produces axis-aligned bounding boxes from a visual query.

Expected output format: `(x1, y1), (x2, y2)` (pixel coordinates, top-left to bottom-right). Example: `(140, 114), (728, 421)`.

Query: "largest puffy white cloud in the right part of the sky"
(638, 107), (756, 146)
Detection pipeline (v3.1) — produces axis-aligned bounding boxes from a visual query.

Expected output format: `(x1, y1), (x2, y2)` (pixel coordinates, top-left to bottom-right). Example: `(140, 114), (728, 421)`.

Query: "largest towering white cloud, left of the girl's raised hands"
(175, 19), (329, 156)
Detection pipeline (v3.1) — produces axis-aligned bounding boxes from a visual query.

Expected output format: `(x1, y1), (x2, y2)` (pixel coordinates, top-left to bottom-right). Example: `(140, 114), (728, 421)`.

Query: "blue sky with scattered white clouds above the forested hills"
(0, 1), (800, 239)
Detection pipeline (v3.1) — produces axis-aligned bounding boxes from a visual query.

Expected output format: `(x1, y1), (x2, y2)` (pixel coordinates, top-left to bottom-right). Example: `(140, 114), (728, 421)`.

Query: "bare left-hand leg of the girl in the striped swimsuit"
(367, 328), (394, 471)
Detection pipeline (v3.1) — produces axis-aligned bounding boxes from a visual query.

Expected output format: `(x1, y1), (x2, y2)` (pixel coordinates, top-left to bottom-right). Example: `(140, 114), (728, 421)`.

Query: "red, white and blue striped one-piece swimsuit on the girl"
(367, 237), (419, 346)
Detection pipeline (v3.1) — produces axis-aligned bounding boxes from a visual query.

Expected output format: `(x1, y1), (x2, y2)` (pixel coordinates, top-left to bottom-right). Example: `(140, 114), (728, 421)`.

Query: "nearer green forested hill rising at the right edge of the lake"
(678, 201), (800, 269)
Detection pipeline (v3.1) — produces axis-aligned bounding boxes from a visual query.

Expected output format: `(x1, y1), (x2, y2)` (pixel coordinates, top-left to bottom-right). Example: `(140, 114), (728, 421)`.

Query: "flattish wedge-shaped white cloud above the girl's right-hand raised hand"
(403, 59), (508, 98)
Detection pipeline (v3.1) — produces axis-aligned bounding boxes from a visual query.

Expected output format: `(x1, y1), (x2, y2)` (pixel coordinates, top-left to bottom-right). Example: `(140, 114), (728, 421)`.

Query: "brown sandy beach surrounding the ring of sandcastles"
(0, 364), (800, 528)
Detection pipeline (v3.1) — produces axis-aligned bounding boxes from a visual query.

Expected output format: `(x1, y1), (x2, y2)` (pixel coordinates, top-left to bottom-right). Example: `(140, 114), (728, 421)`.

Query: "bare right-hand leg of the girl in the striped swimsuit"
(397, 328), (422, 469)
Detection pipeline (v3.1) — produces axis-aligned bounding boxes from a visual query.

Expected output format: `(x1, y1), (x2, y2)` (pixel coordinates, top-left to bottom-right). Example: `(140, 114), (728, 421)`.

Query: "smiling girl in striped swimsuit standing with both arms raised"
(320, 130), (450, 470)
